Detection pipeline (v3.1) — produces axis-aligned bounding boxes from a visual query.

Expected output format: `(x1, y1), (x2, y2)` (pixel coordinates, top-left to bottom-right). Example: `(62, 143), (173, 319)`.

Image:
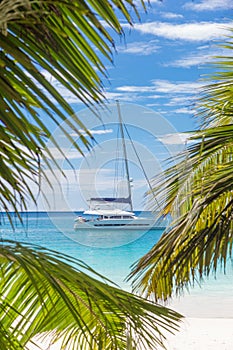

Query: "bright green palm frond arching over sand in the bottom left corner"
(0, 242), (181, 350)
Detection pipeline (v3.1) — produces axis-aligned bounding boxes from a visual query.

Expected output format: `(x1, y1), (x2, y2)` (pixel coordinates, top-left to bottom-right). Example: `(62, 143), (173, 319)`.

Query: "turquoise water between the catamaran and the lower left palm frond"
(1, 213), (163, 290)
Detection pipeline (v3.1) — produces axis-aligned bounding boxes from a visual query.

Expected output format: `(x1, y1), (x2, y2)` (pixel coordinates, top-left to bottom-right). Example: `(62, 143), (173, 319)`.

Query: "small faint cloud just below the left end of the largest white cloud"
(118, 40), (160, 56)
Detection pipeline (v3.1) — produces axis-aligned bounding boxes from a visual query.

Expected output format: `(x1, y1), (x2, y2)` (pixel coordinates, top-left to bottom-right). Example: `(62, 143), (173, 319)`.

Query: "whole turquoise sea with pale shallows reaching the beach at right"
(0, 212), (233, 317)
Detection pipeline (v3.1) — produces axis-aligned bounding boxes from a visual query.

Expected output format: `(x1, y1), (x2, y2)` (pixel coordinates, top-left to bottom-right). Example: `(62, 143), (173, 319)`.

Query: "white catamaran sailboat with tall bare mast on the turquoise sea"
(74, 102), (164, 231)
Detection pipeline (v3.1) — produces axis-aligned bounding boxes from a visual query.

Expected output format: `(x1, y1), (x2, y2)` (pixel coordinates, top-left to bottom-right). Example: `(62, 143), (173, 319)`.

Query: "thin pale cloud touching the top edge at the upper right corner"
(184, 0), (233, 11)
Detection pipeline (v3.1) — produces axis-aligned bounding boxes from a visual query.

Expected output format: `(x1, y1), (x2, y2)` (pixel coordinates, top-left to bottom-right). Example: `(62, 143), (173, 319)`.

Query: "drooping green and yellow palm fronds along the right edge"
(130, 32), (233, 299)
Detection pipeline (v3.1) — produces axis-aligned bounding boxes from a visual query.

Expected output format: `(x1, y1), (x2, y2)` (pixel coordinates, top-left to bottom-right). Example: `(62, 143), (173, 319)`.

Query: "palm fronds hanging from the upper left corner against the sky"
(0, 0), (144, 210)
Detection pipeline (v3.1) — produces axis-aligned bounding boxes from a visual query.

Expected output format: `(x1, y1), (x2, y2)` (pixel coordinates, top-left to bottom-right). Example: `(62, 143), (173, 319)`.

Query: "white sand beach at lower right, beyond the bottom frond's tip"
(30, 294), (233, 350)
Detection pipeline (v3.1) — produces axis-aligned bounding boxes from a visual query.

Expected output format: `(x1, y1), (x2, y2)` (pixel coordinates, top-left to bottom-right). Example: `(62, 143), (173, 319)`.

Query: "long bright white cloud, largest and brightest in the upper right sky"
(134, 22), (232, 42)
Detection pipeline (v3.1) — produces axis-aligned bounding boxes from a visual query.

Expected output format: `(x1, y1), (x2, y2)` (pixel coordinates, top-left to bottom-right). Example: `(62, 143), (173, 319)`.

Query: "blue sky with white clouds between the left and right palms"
(40, 0), (233, 210)
